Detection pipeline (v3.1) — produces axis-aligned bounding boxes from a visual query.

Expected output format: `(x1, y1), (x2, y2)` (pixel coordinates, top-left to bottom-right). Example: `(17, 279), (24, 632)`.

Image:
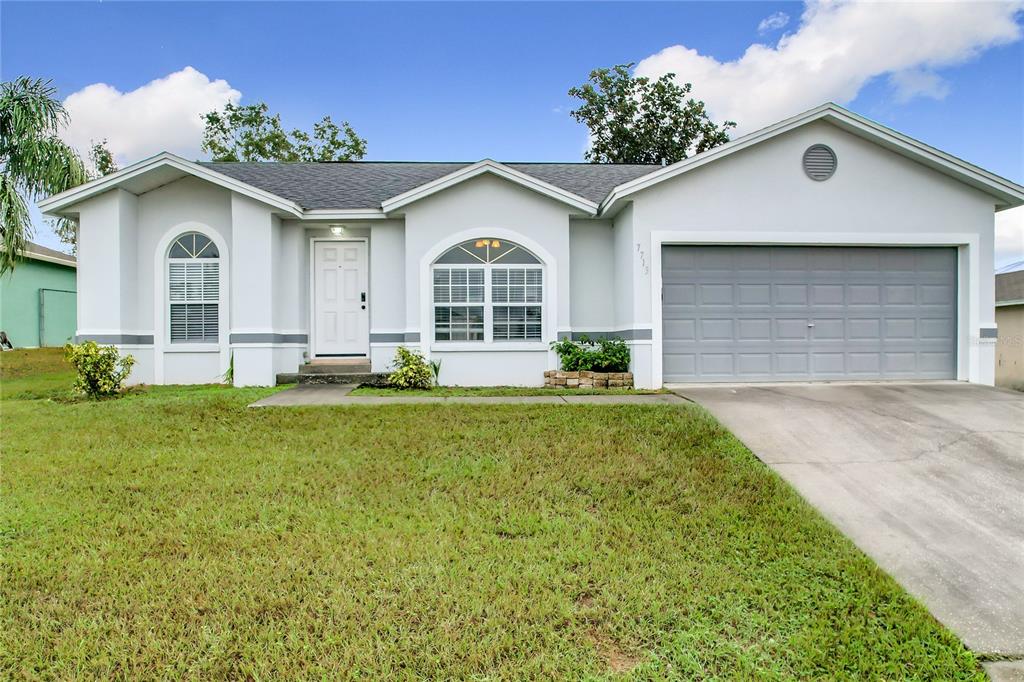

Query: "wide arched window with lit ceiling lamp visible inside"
(433, 238), (544, 342)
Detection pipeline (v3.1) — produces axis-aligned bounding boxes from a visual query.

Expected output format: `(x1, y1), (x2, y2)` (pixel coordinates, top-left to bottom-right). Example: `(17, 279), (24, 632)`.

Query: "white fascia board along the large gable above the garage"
(598, 102), (1024, 216)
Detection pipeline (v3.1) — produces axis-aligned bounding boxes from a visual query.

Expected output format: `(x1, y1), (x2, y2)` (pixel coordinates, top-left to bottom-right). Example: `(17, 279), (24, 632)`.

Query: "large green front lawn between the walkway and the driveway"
(0, 348), (983, 680)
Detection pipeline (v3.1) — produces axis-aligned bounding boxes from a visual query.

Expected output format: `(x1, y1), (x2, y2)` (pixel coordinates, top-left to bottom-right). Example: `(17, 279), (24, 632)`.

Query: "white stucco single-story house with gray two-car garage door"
(40, 104), (1024, 387)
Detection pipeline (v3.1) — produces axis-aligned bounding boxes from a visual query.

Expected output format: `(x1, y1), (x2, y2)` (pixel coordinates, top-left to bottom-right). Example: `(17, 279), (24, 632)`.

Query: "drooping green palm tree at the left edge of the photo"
(0, 77), (86, 274)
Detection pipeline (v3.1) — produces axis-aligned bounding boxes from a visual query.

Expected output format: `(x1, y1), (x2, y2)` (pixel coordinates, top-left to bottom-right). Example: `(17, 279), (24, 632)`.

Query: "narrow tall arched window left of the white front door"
(167, 232), (220, 343)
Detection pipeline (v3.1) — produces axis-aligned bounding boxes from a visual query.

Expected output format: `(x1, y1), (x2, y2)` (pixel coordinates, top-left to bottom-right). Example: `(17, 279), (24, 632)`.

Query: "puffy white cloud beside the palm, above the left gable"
(62, 67), (242, 165)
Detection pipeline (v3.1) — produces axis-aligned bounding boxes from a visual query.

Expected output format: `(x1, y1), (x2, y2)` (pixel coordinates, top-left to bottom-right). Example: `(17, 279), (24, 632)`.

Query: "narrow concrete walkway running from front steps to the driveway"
(249, 384), (686, 408)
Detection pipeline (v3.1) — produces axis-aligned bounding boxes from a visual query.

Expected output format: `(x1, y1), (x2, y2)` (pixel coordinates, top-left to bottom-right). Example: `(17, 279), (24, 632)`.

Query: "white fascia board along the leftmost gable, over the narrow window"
(37, 152), (302, 218)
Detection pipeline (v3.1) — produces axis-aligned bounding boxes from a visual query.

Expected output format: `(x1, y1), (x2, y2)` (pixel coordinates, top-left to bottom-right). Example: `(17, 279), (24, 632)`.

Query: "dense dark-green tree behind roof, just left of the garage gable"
(569, 63), (736, 164)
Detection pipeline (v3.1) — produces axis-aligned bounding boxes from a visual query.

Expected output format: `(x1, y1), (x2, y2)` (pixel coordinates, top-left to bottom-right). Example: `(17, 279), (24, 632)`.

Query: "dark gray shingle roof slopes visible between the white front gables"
(202, 161), (660, 210)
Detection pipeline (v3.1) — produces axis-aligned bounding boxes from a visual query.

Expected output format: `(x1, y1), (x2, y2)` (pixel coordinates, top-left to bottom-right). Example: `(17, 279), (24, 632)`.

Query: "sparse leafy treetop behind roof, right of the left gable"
(203, 102), (367, 161)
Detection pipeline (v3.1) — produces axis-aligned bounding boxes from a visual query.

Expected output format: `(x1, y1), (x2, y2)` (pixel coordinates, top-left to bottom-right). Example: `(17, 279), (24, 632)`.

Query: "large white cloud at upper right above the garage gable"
(636, 0), (1024, 132)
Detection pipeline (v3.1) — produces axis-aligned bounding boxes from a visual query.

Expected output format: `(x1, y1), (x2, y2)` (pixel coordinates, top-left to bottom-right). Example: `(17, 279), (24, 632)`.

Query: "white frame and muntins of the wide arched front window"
(428, 240), (549, 349)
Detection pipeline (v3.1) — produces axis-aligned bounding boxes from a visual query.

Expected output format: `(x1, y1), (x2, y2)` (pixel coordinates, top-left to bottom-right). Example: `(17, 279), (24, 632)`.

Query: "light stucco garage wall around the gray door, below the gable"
(616, 122), (994, 385)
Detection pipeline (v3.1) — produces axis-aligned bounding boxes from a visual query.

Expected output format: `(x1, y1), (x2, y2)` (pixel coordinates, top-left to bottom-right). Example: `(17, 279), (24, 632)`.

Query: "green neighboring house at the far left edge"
(0, 242), (78, 348)
